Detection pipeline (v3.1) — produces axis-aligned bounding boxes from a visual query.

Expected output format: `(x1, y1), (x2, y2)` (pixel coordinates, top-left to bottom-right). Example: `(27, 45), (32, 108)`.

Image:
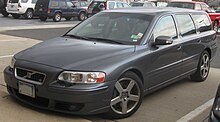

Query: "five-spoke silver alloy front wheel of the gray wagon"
(110, 78), (141, 114)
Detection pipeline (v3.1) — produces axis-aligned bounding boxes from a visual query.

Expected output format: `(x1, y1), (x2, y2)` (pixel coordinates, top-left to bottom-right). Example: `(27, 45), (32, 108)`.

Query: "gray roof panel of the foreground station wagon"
(104, 7), (205, 15)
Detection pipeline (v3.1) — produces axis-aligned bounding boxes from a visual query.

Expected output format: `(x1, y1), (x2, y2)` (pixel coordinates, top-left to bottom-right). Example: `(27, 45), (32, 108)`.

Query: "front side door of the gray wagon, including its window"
(146, 15), (182, 89)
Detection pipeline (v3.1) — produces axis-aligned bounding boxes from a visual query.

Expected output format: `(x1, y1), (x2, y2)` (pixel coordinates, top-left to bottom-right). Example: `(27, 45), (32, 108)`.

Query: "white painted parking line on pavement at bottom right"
(176, 98), (214, 122)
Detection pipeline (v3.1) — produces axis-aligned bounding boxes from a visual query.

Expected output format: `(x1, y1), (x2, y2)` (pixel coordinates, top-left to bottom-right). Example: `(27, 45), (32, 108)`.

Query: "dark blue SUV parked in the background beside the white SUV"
(35, 0), (87, 22)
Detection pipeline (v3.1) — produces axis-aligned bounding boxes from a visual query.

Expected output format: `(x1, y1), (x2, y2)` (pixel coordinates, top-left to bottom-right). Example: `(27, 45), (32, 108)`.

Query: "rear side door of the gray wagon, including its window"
(175, 14), (204, 73)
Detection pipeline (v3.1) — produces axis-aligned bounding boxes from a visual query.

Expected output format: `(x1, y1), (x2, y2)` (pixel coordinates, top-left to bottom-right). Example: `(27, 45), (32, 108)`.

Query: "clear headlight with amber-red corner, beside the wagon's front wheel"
(58, 71), (105, 83)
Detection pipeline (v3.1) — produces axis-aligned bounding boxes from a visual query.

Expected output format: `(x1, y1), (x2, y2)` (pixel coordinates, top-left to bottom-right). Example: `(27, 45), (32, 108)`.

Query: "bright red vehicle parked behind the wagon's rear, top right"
(167, 1), (220, 32)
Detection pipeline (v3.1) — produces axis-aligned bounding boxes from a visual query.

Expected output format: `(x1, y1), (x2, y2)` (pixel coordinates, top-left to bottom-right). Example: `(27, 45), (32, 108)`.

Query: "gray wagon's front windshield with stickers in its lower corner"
(66, 12), (153, 44)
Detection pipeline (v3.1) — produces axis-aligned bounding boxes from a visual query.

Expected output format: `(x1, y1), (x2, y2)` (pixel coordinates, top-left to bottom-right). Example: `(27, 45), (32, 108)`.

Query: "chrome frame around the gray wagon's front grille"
(14, 67), (47, 85)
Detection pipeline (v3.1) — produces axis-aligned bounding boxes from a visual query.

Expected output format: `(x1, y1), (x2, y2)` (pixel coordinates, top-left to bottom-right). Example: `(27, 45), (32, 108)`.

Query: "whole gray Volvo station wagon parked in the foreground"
(4, 8), (217, 118)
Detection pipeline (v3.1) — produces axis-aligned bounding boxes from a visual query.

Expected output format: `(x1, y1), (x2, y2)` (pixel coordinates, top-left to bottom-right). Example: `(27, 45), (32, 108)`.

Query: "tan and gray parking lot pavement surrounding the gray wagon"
(0, 16), (220, 122)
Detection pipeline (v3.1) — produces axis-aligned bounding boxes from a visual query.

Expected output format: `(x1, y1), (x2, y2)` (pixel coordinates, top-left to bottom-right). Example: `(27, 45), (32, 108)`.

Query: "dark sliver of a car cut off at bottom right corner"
(209, 85), (220, 122)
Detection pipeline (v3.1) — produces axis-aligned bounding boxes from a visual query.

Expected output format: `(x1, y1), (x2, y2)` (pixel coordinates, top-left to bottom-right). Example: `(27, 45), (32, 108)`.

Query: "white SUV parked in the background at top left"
(6, 0), (37, 19)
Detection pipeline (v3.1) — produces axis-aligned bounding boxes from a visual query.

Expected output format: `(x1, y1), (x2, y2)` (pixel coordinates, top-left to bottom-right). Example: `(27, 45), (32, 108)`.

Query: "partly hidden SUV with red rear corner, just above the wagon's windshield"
(88, 0), (130, 17)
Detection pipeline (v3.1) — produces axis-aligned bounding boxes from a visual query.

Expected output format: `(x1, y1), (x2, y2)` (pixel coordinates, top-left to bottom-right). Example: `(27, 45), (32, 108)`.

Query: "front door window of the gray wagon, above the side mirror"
(153, 16), (177, 39)
